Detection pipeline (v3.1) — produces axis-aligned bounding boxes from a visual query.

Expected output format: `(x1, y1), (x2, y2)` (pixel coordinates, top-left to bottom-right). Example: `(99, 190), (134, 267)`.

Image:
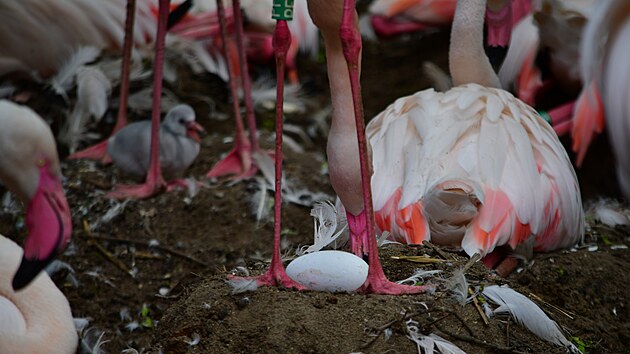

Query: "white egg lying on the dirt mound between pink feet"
(287, 251), (368, 292)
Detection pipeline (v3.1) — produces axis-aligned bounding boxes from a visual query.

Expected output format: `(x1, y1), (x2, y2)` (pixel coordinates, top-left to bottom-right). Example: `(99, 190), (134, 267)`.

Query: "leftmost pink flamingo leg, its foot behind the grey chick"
(68, 0), (136, 163)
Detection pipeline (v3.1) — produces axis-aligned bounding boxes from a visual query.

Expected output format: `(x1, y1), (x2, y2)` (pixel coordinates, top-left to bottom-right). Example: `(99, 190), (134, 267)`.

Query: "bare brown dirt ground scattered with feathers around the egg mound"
(0, 24), (630, 353)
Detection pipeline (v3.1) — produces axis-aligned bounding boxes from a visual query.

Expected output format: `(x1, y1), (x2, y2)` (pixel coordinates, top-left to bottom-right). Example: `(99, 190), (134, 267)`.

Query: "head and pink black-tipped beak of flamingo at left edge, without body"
(0, 100), (72, 290)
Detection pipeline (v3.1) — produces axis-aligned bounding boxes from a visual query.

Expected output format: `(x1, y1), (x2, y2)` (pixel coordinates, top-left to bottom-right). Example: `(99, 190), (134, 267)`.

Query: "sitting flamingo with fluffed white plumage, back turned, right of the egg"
(367, 0), (584, 272)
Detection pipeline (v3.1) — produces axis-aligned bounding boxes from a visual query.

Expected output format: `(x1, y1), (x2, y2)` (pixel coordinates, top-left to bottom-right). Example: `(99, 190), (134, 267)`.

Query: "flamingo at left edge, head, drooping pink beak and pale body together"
(0, 100), (78, 354)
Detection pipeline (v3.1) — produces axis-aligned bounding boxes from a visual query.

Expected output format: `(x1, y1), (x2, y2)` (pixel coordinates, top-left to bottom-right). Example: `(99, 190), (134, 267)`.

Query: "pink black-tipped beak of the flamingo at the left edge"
(13, 162), (72, 291)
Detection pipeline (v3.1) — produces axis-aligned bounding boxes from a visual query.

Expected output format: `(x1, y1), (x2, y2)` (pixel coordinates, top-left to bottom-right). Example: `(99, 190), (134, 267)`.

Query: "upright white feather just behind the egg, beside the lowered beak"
(296, 201), (348, 256)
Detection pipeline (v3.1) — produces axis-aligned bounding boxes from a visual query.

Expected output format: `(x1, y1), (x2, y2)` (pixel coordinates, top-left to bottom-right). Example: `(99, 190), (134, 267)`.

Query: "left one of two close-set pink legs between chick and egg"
(206, 0), (258, 179)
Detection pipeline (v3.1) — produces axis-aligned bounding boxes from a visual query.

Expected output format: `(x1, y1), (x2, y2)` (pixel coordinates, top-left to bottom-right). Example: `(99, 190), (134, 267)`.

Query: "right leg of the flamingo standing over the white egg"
(340, 0), (429, 295)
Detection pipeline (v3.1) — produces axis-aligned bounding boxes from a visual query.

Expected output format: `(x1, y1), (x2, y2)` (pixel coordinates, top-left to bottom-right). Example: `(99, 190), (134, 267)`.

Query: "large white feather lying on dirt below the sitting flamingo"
(482, 285), (579, 353)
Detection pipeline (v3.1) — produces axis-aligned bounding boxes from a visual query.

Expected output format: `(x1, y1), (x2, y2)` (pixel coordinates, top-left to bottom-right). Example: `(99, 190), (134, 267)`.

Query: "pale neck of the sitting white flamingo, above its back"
(449, 0), (501, 88)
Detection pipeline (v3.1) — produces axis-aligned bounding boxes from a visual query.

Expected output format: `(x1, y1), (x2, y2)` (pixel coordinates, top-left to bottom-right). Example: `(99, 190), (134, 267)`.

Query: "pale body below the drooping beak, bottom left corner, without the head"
(0, 235), (79, 354)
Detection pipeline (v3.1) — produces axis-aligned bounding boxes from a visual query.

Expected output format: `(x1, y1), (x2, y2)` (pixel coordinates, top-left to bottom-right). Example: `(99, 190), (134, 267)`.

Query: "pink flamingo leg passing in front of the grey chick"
(107, 0), (170, 199)
